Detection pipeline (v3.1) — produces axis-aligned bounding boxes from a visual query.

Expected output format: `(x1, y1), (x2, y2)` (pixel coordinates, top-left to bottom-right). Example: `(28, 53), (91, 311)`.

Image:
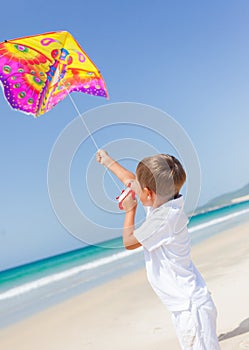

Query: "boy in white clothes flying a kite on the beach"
(96, 150), (220, 350)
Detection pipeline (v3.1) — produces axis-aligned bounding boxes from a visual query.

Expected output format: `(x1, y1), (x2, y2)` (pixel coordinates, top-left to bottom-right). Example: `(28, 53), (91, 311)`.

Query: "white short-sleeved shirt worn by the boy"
(134, 196), (209, 311)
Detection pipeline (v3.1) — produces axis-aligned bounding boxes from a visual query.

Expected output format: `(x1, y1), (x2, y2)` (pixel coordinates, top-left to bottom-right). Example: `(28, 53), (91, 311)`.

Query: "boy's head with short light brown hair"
(136, 154), (186, 202)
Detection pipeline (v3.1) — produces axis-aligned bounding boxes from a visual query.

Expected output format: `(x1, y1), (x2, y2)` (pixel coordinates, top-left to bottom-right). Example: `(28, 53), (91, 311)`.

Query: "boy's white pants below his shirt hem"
(172, 298), (220, 350)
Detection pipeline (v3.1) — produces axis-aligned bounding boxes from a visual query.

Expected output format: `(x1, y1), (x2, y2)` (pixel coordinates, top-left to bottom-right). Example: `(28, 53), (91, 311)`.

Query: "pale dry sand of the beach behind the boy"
(0, 224), (249, 350)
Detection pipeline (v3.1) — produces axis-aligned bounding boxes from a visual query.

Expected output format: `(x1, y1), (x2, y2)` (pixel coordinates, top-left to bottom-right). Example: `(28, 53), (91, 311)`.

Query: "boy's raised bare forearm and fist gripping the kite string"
(96, 149), (135, 186)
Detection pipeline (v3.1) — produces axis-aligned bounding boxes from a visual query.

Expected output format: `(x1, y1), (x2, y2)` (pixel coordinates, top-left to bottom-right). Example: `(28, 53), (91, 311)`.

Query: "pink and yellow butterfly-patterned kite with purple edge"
(0, 31), (108, 116)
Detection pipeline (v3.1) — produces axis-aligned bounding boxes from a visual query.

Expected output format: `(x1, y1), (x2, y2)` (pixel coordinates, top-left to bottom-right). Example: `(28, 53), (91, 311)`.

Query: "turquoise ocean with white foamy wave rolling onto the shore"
(0, 201), (249, 327)
